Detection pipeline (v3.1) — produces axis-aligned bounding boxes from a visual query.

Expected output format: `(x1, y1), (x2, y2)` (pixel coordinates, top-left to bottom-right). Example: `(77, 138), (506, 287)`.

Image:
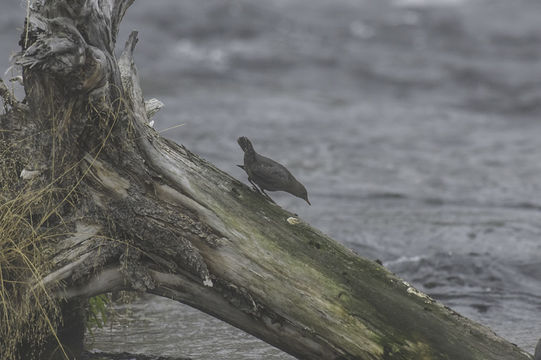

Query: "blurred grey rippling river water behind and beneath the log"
(0, 0), (541, 359)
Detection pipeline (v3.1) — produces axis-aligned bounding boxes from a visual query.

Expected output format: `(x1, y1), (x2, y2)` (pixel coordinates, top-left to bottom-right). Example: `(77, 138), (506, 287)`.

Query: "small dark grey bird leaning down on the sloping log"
(237, 136), (312, 205)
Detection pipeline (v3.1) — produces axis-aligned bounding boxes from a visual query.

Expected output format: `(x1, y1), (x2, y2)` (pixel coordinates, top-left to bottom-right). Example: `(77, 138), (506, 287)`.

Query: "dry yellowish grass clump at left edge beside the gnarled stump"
(0, 121), (69, 360)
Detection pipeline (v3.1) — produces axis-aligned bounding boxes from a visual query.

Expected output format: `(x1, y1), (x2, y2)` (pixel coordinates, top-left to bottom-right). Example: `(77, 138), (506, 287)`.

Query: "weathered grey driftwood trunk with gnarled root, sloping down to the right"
(2, 0), (531, 360)
